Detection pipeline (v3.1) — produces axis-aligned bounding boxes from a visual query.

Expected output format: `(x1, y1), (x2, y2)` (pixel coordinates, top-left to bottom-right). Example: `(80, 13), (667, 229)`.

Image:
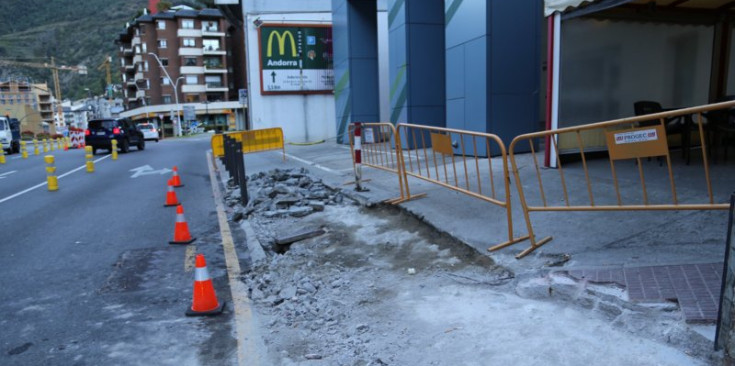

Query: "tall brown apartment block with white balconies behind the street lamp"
(117, 9), (237, 109)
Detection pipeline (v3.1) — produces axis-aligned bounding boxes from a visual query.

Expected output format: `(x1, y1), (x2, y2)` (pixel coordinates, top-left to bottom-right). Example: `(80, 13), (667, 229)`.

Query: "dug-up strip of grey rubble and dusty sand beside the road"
(223, 170), (717, 366)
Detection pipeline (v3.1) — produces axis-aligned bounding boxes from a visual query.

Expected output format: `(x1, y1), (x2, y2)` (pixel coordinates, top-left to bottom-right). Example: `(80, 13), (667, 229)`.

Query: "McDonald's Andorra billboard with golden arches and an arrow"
(258, 24), (334, 94)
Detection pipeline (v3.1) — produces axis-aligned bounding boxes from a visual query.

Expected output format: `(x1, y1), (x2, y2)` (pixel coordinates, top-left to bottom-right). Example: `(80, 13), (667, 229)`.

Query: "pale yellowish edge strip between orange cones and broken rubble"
(205, 151), (265, 366)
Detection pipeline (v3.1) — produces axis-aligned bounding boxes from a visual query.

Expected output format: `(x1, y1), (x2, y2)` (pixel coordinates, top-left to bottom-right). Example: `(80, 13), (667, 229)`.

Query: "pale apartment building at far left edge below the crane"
(0, 78), (56, 133)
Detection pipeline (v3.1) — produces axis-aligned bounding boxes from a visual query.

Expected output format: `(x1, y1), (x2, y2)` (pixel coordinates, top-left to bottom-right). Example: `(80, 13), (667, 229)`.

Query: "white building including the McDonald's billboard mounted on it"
(216, 0), (336, 142)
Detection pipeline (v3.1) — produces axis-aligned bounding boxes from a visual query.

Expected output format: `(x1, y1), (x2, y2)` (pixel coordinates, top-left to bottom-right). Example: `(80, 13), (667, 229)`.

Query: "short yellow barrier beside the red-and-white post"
(348, 122), (417, 203)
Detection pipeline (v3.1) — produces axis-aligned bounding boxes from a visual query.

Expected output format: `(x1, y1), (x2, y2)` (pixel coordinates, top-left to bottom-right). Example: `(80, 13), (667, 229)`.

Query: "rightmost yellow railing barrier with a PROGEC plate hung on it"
(506, 102), (735, 258)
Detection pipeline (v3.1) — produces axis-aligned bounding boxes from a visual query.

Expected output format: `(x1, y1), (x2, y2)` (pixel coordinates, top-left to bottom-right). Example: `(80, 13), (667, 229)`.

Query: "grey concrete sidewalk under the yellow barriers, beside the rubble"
(239, 142), (735, 323)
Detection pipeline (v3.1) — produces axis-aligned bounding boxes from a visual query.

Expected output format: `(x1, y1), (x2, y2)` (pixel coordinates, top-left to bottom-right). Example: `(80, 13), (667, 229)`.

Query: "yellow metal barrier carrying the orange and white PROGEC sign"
(506, 102), (735, 258)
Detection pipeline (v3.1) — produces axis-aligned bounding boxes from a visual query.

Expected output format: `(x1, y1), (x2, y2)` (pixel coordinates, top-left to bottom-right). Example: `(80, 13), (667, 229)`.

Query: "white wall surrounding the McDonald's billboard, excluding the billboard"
(243, 0), (337, 142)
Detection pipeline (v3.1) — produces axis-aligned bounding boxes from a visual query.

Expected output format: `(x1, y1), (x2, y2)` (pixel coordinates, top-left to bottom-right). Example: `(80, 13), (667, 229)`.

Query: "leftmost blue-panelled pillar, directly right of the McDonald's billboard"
(332, 0), (379, 143)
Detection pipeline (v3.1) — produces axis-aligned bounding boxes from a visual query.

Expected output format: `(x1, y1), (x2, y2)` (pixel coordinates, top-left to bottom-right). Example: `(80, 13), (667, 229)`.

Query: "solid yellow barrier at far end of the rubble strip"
(211, 127), (286, 160)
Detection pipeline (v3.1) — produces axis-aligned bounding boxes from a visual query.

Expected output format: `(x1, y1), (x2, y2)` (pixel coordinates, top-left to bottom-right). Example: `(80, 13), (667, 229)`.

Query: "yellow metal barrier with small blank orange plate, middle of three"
(396, 123), (528, 248)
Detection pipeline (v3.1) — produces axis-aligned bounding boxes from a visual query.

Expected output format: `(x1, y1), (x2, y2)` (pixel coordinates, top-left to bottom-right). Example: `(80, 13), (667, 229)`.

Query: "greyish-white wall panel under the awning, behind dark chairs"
(559, 18), (713, 126)
